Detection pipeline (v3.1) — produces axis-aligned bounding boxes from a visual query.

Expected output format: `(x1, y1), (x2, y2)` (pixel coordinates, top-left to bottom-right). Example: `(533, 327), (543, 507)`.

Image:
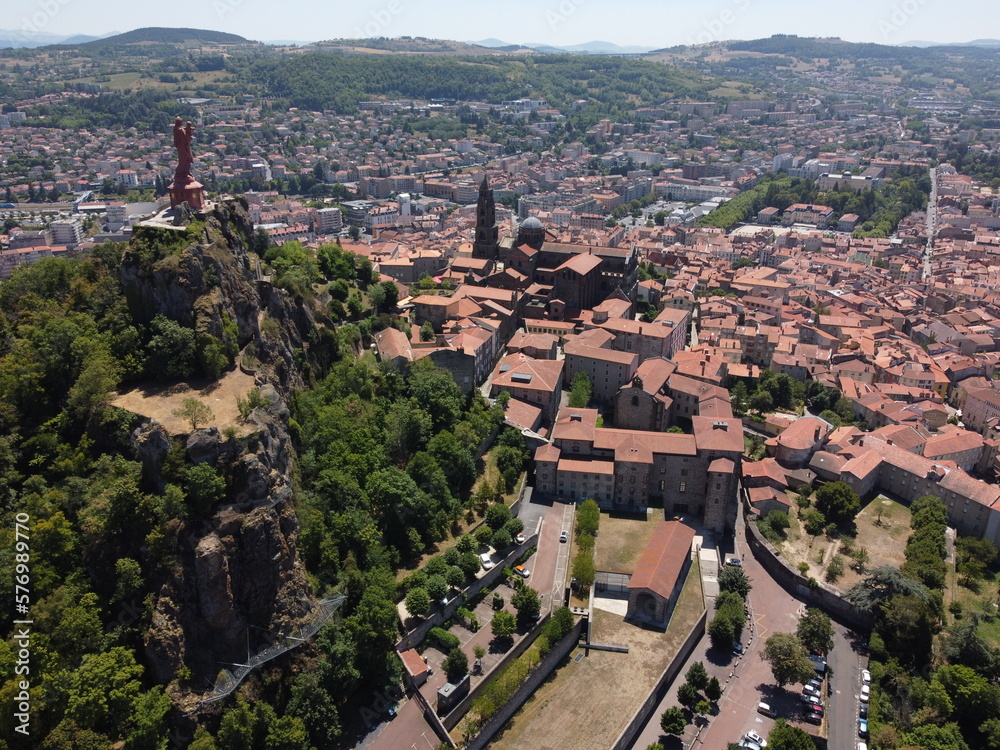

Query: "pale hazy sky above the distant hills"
(7, 0), (1000, 47)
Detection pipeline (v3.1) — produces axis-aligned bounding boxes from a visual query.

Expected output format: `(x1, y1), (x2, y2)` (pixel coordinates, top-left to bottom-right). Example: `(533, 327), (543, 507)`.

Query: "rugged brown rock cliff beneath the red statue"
(121, 200), (315, 706)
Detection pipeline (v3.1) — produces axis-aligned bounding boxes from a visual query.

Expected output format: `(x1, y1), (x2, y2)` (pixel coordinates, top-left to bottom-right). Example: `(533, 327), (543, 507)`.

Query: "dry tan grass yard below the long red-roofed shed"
(490, 560), (704, 750)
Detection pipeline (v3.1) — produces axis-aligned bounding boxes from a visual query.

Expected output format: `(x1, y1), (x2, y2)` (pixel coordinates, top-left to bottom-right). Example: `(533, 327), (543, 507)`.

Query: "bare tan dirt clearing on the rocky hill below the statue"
(111, 367), (254, 436)
